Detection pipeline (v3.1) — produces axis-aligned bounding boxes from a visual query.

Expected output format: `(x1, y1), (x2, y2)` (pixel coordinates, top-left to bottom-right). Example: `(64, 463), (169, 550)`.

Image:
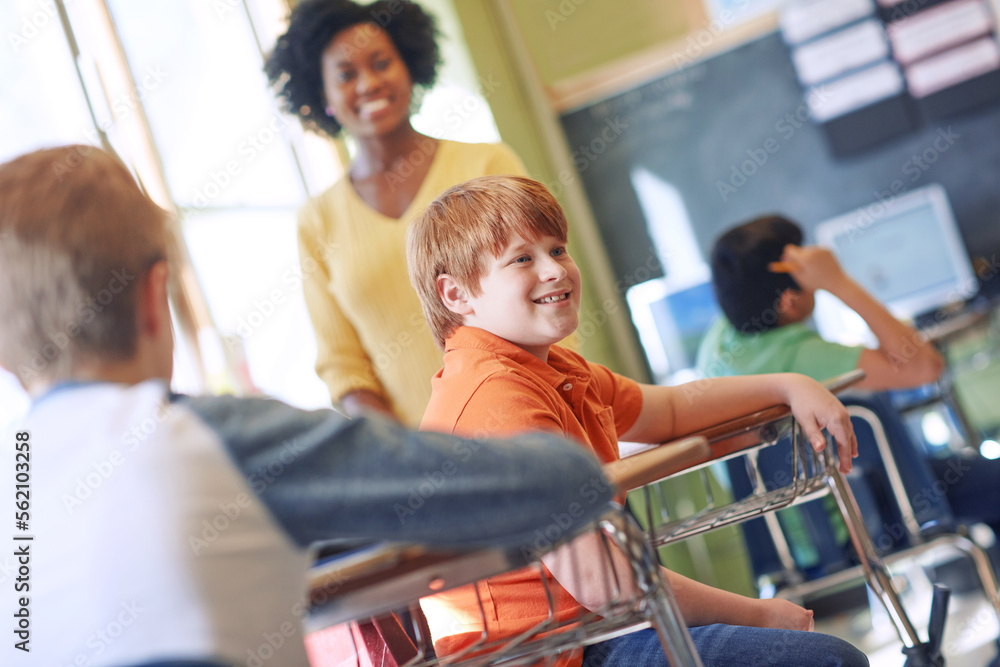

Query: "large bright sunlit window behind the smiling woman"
(0, 0), (508, 428)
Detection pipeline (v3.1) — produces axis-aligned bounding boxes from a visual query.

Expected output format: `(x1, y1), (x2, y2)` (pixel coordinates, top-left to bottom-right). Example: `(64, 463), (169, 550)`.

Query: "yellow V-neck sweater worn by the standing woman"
(299, 140), (525, 427)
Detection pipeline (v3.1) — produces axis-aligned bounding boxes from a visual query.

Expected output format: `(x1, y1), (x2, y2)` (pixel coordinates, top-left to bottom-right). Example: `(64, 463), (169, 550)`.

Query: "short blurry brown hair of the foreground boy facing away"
(0, 145), (166, 386)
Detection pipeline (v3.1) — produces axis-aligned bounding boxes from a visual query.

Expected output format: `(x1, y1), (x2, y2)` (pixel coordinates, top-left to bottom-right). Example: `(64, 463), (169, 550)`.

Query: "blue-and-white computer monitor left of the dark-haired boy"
(625, 269), (720, 384)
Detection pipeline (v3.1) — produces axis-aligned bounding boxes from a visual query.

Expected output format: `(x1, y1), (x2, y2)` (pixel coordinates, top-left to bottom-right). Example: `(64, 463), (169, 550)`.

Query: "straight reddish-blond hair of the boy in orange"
(406, 176), (567, 349)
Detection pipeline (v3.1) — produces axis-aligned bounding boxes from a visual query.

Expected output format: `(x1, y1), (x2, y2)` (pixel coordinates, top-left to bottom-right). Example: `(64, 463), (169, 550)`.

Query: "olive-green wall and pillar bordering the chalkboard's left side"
(454, 0), (678, 381)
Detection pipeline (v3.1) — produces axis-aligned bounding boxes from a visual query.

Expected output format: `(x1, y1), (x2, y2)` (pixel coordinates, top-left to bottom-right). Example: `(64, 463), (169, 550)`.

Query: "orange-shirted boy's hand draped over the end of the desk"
(785, 373), (858, 474)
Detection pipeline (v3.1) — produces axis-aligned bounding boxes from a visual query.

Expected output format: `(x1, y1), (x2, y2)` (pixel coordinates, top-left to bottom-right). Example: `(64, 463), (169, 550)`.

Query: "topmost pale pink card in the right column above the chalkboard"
(886, 0), (993, 65)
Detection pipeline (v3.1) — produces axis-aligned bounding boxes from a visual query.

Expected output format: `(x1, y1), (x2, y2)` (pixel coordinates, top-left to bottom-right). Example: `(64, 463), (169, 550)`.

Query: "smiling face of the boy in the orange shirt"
(463, 235), (580, 361)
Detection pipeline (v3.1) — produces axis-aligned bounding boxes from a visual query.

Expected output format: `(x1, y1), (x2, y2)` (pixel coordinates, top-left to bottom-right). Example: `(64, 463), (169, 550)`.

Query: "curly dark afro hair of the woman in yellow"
(264, 0), (441, 137)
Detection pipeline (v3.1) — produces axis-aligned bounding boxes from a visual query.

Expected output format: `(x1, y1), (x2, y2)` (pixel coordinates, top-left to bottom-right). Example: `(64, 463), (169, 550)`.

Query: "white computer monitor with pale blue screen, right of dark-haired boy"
(814, 184), (976, 343)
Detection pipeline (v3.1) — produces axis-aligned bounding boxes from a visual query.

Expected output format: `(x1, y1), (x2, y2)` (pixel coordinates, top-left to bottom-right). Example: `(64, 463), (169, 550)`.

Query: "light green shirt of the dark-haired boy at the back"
(697, 317), (864, 382)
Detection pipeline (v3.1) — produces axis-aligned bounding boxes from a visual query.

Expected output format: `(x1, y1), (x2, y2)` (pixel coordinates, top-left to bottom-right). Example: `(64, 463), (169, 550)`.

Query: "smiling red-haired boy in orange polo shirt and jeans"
(407, 176), (868, 667)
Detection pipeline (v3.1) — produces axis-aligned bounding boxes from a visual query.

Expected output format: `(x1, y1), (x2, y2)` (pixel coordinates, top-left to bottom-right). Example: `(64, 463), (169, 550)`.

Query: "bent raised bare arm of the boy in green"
(782, 245), (944, 389)
